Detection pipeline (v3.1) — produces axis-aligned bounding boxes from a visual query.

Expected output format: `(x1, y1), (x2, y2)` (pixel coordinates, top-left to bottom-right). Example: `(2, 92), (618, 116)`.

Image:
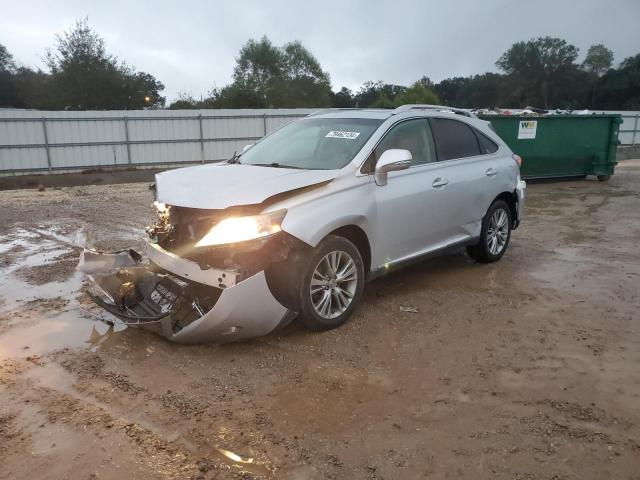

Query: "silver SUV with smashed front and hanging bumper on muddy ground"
(79, 105), (526, 343)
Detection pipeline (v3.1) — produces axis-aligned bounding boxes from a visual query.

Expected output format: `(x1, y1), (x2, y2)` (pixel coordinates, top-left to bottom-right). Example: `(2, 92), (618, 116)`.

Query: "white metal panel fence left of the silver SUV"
(0, 109), (317, 175)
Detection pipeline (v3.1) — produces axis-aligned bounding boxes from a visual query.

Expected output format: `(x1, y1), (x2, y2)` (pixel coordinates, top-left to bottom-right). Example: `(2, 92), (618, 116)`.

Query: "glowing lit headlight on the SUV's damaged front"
(195, 209), (287, 247)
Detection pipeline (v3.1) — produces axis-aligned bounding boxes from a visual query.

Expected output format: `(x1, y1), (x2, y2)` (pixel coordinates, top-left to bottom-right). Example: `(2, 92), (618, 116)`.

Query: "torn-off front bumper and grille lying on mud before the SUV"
(78, 242), (295, 343)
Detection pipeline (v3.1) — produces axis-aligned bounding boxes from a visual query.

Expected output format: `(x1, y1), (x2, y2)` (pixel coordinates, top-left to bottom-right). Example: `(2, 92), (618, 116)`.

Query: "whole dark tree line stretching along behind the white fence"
(0, 19), (640, 110)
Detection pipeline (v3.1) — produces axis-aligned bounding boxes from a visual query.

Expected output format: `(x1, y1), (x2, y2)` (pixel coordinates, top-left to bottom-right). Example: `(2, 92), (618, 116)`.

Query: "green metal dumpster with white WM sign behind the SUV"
(480, 114), (622, 180)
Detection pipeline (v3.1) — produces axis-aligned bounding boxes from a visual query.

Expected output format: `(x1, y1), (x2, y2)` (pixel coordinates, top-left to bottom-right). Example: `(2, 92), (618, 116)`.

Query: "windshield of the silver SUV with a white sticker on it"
(240, 118), (383, 170)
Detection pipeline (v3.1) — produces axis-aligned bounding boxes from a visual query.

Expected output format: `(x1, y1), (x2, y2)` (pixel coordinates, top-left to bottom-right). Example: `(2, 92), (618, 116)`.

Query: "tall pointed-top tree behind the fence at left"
(45, 19), (164, 110)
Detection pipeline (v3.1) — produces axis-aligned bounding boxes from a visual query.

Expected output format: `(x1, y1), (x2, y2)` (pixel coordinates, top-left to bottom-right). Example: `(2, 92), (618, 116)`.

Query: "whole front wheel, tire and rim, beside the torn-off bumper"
(297, 235), (365, 330)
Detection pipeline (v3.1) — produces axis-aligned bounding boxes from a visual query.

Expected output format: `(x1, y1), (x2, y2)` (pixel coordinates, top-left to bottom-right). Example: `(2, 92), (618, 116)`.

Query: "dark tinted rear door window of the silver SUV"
(429, 118), (480, 161)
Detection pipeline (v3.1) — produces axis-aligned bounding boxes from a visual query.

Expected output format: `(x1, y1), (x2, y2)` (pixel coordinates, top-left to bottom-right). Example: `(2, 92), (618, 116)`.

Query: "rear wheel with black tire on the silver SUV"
(467, 200), (513, 263)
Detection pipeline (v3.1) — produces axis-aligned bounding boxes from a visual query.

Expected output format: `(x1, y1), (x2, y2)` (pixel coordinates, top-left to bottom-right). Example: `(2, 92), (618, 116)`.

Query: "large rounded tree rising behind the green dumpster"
(496, 37), (578, 108)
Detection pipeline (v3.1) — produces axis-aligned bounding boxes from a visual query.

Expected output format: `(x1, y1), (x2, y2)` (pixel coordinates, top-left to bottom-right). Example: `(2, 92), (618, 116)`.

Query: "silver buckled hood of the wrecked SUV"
(156, 163), (337, 209)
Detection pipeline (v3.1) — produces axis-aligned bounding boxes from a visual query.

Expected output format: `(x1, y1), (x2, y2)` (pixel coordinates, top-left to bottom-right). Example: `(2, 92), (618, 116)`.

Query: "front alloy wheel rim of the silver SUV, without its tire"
(309, 250), (358, 319)
